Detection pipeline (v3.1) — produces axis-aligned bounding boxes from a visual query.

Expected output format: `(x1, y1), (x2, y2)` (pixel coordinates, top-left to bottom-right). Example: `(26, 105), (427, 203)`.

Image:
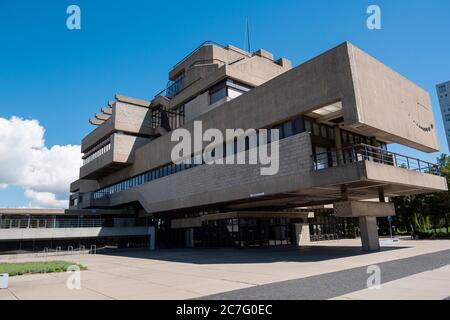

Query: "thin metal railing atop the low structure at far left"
(0, 218), (105, 229)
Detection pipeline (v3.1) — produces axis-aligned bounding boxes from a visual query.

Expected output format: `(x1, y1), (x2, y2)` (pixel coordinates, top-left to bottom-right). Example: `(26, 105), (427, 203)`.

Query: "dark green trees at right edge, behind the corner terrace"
(393, 154), (450, 234)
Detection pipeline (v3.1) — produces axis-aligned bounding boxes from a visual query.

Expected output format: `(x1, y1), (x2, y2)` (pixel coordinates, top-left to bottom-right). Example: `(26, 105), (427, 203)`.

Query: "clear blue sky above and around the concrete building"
(0, 0), (450, 207)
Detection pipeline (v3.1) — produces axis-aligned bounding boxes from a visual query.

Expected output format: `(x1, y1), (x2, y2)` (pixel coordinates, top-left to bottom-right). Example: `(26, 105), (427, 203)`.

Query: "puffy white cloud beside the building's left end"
(0, 117), (82, 207)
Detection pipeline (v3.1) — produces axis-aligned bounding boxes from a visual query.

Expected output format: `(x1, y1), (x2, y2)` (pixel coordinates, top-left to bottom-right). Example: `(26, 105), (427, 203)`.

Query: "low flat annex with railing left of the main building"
(0, 208), (155, 254)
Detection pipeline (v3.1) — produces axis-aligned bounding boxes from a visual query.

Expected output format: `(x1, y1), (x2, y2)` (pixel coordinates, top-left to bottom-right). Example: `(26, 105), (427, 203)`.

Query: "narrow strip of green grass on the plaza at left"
(0, 261), (86, 277)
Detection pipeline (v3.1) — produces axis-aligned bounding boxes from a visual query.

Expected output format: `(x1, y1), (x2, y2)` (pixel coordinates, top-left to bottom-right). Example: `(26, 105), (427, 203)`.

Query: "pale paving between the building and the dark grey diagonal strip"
(0, 240), (450, 300)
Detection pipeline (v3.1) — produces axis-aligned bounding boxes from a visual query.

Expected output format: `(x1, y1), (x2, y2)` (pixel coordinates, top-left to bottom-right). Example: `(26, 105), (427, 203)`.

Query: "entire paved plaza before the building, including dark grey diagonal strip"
(0, 240), (450, 300)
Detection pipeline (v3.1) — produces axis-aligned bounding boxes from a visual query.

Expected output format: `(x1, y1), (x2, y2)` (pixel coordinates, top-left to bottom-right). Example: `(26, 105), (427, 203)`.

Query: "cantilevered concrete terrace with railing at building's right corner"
(310, 144), (448, 202)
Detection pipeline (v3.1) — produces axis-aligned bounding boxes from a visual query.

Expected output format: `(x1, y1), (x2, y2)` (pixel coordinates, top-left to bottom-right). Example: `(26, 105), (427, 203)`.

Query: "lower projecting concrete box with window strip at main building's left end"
(80, 133), (150, 180)
